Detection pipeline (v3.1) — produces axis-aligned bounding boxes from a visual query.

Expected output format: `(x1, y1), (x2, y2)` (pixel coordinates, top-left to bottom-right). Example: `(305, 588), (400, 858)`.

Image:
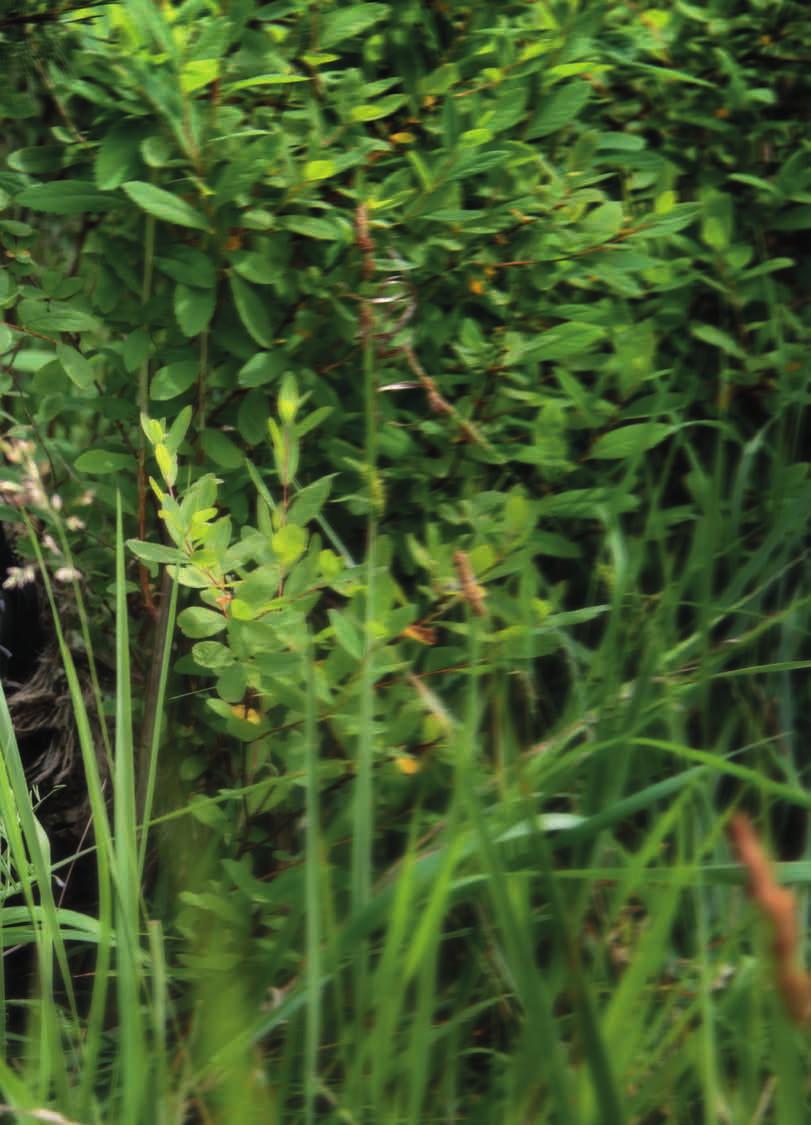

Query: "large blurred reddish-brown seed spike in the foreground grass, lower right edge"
(729, 812), (811, 1025)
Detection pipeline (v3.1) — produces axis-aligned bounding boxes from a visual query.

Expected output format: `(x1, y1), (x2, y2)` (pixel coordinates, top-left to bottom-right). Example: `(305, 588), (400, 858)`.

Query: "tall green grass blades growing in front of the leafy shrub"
(0, 407), (811, 1125)
